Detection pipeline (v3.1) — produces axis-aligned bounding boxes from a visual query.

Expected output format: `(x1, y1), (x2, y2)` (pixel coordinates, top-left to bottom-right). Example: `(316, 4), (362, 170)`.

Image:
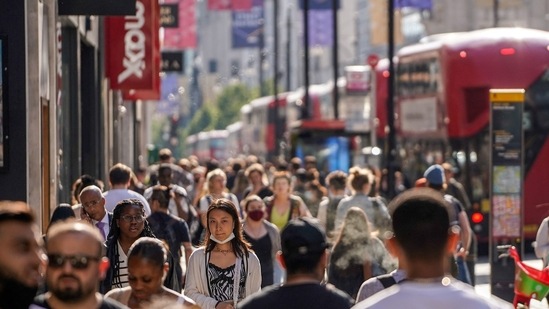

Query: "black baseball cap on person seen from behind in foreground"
(280, 218), (328, 257)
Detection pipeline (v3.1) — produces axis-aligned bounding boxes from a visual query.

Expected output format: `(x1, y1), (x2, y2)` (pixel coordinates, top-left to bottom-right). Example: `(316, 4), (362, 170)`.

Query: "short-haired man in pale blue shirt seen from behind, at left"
(105, 163), (151, 216)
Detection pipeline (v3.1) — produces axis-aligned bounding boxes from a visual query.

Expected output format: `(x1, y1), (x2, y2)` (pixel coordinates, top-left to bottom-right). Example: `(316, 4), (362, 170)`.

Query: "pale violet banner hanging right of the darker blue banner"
(309, 10), (334, 47)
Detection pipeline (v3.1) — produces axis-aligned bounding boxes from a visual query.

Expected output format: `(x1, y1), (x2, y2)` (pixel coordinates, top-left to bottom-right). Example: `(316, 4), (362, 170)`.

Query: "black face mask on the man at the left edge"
(0, 275), (38, 309)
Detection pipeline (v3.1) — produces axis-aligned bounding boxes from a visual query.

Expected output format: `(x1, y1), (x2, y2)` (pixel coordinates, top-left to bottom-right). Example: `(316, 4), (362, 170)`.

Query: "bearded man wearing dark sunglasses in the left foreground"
(31, 221), (125, 309)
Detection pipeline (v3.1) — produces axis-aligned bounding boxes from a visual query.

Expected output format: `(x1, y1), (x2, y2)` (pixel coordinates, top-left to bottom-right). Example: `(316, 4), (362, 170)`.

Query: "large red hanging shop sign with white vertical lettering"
(105, 0), (160, 97)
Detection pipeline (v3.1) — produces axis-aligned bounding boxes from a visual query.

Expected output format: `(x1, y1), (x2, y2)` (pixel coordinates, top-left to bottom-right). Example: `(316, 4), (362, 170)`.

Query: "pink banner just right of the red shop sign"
(162, 0), (196, 49)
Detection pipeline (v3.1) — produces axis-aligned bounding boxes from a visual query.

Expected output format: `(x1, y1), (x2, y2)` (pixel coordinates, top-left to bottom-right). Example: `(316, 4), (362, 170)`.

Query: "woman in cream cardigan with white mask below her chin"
(185, 198), (261, 309)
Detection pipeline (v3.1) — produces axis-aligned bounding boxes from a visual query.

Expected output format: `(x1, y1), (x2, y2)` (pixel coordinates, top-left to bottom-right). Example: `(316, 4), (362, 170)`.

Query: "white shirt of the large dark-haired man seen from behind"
(353, 277), (513, 309)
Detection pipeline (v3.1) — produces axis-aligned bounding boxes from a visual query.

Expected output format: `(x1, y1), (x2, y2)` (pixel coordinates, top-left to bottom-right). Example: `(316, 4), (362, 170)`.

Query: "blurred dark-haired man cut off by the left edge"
(0, 201), (45, 309)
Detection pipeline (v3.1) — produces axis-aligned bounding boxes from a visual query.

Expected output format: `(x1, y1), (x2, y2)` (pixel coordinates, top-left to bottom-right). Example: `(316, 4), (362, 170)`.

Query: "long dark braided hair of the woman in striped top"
(100, 199), (156, 294)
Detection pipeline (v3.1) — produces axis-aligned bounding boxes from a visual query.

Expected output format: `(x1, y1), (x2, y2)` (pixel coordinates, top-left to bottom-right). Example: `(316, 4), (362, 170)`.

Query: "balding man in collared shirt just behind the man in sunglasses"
(80, 186), (112, 240)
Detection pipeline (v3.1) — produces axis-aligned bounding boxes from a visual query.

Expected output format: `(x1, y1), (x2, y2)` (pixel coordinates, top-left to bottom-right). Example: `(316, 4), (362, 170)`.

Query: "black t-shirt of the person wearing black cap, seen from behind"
(237, 283), (354, 309)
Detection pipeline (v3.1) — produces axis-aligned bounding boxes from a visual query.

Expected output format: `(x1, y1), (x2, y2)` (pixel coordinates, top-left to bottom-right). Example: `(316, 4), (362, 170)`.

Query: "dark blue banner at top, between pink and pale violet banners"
(231, 0), (263, 48)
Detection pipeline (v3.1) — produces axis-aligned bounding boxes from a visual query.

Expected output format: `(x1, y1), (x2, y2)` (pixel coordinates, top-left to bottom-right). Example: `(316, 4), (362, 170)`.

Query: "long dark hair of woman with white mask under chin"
(204, 198), (252, 258)
